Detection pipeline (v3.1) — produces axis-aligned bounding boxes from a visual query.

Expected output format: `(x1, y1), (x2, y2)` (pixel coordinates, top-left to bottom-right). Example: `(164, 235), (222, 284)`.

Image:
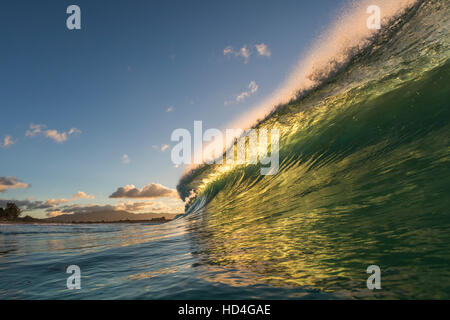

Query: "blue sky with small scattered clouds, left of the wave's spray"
(0, 0), (344, 218)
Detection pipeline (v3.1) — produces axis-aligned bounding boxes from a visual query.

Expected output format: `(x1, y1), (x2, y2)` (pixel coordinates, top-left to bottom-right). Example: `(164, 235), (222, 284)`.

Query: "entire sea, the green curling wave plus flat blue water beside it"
(0, 0), (450, 299)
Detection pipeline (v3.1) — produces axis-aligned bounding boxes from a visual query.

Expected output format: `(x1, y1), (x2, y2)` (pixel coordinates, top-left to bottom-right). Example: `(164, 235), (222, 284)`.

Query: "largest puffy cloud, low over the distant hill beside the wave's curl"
(109, 183), (178, 199)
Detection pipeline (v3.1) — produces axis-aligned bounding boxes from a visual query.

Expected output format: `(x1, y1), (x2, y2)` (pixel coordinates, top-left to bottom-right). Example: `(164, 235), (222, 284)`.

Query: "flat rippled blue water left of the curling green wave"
(0, 219), (328, 299)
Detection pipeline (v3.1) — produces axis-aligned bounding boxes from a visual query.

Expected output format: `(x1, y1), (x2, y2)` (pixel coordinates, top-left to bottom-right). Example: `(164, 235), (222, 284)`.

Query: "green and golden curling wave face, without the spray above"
(179, 1), (450, 299)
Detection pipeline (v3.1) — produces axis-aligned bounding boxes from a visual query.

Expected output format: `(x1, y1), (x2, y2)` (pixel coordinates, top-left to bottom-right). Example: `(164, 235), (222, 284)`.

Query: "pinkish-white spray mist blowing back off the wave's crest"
(231, 0), (422, 128)
